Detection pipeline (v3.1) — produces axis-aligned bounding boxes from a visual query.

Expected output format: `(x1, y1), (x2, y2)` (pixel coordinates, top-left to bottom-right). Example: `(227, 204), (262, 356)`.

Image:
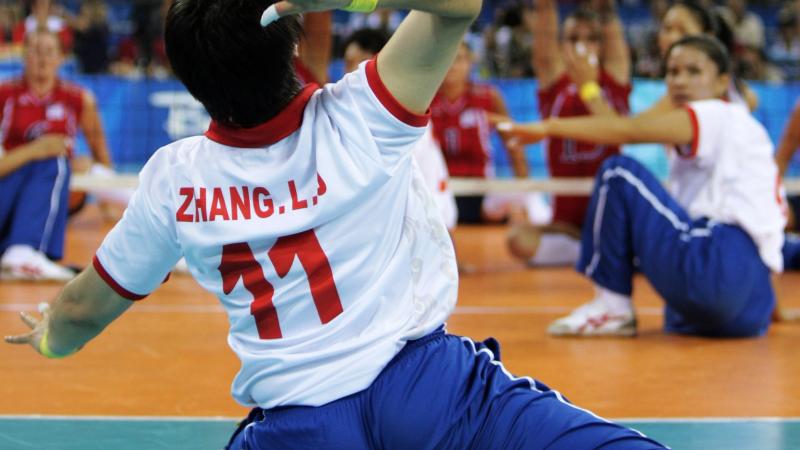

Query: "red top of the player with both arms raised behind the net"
(539, 71), (631, 232)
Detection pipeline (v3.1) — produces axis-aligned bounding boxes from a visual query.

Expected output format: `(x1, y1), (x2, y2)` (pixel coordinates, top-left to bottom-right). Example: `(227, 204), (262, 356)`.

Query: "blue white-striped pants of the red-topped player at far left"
(0, 158), (70, 259)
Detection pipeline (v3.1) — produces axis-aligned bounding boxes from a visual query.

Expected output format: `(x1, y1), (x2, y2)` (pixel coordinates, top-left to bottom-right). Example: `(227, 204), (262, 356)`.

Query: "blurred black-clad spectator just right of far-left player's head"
(73, 0), (110, 74)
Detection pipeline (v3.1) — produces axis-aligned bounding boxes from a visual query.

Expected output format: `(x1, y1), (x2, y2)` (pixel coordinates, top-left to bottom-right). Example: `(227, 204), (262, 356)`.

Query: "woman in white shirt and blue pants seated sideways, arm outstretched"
(501, 35), (786, 337)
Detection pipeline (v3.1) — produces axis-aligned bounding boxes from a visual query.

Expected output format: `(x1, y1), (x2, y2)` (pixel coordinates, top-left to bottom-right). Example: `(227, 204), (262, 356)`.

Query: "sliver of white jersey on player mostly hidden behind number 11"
(413, 125), (458, 230)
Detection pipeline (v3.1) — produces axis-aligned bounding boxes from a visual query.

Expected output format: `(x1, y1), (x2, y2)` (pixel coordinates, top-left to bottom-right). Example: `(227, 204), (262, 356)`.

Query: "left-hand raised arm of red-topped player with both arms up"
(525, 0), (564, 89)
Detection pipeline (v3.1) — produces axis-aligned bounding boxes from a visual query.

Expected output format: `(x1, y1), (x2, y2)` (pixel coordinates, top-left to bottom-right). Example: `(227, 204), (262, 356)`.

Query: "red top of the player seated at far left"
(0, 79), (83, 153)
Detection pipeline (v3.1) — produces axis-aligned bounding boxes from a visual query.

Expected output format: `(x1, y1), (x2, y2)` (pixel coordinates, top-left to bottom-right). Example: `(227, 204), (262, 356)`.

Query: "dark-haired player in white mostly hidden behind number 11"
(344, 28), (458, 233)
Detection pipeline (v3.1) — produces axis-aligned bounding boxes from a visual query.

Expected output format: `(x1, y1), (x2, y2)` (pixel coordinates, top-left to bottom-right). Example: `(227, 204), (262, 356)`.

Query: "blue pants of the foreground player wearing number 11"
(227, 329), (664, 450)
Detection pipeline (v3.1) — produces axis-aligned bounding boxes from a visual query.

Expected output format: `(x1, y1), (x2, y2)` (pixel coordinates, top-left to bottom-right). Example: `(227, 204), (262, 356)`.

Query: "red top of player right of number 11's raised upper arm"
(431, 84), (496, 177)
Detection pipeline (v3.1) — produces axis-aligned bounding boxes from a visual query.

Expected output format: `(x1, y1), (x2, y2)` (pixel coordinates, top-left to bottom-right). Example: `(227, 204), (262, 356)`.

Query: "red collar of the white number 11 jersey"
(206, 84), (319, 148)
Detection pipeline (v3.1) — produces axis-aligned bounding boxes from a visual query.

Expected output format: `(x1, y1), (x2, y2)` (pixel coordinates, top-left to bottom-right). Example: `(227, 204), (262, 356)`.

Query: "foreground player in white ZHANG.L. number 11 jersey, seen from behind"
(7, 0), (663, 450)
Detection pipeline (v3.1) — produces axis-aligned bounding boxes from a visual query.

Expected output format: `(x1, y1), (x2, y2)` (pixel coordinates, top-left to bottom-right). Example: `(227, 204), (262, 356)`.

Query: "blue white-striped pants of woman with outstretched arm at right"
(577, 156), (775, 337)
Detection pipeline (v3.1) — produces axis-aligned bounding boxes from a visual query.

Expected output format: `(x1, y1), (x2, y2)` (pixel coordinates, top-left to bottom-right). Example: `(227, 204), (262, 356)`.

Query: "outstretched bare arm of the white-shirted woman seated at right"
(497, 109), (694, 145)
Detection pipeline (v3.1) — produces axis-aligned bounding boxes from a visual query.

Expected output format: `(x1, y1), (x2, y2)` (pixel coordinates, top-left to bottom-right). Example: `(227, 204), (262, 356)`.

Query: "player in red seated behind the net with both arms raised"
(507, 0), (631, 266)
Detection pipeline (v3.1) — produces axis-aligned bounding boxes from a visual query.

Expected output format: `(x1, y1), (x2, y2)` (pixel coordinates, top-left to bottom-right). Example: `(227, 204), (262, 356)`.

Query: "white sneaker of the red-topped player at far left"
(0, 246), (75, 281)
